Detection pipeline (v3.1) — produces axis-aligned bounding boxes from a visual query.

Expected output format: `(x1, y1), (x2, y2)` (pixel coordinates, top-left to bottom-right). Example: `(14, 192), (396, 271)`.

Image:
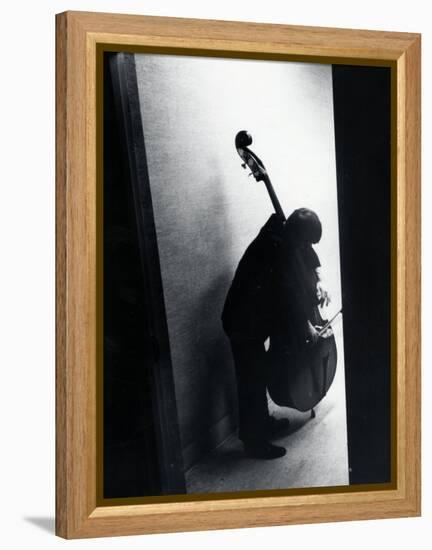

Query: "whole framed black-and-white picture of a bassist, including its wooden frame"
(56, 12), (420, 538)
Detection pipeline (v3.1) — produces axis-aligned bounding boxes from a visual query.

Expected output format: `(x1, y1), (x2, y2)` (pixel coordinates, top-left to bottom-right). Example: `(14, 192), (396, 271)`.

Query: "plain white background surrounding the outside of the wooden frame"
(0, 0), (432, 550)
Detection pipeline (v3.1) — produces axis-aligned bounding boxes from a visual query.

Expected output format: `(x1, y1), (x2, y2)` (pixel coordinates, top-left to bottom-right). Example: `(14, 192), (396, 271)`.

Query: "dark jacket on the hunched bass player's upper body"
(222, 214), (320, 341)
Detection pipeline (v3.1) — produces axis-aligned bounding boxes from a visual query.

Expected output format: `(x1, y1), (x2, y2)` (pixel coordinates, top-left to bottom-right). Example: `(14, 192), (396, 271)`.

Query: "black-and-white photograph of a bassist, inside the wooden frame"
(104, 51), (395, 502)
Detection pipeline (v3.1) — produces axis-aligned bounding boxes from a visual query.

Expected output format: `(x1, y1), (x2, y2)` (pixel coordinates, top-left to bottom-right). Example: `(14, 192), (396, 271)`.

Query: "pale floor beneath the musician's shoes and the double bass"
(186, 334), (348, 493)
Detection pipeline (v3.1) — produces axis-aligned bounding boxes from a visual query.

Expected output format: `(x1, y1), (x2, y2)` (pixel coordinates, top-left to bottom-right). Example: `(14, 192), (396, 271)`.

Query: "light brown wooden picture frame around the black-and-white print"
(56, 12), (420, 538)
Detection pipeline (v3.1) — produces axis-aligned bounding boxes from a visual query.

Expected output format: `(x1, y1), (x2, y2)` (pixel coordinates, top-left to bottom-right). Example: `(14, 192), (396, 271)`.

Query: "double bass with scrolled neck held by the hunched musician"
(235, 130), (342, 418)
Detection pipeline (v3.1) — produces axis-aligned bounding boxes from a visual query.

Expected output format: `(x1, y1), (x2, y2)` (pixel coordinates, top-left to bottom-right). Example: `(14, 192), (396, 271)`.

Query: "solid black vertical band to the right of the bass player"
(333, 65), (392, 484)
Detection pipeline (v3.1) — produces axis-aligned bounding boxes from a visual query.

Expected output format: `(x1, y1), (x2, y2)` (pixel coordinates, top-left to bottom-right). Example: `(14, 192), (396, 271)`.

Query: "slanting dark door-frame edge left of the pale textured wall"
(106, 53), (185, 496)
